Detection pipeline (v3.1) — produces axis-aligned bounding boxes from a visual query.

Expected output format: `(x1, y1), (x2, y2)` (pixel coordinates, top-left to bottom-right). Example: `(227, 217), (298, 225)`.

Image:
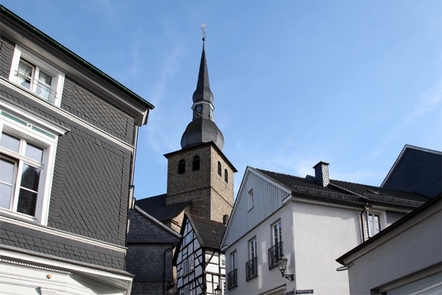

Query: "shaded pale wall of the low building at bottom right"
(348, 207), (442, 294)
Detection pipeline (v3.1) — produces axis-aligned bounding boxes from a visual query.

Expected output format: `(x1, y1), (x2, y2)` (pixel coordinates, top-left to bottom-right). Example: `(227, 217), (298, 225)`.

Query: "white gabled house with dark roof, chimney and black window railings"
(221, 162), (428, 294)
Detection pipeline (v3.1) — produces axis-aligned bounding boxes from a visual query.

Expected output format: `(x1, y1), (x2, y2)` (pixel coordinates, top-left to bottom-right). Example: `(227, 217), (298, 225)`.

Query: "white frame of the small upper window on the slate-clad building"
(9, 45), (65, 107)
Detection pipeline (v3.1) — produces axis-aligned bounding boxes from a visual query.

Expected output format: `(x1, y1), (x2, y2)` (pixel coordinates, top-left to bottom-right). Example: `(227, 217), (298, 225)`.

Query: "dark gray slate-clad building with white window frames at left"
(0, 6), (153, 295)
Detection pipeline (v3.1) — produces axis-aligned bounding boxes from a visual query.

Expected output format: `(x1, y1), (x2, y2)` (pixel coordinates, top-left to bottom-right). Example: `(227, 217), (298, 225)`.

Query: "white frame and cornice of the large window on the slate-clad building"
(0, 102), (67, 225)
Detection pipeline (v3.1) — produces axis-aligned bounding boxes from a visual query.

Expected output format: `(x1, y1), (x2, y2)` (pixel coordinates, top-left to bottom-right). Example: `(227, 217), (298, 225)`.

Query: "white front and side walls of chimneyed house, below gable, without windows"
(226, 202), (362, 295)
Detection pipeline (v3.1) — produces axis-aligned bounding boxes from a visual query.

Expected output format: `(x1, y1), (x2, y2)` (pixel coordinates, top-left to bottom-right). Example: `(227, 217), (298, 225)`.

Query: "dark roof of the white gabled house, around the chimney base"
(256, 169), (428, 208)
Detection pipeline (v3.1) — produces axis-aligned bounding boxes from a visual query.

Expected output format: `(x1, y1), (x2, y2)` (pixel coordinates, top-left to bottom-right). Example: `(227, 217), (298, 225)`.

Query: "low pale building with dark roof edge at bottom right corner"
(337, 195), (442, 295)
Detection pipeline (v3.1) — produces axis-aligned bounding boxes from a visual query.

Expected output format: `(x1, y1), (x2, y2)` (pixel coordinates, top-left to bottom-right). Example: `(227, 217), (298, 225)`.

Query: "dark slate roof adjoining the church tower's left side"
(136, 194), (192, 221)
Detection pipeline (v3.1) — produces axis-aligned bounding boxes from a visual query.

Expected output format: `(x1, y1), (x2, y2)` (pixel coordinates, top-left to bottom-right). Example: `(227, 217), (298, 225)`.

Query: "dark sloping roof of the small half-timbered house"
(186, 215), (226, 249)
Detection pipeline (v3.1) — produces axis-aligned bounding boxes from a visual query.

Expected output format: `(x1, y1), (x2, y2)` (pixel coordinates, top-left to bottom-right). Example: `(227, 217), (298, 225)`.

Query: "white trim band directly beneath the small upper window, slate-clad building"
(0, 77), (134, 152)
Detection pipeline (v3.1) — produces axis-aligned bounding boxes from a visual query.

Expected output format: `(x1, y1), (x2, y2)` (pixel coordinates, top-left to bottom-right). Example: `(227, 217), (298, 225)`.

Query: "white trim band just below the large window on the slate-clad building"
(0, 215), (127, 253)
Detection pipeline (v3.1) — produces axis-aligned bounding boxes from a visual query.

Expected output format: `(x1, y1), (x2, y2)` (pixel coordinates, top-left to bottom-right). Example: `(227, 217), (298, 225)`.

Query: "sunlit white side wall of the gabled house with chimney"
(291, 202), (362, 294)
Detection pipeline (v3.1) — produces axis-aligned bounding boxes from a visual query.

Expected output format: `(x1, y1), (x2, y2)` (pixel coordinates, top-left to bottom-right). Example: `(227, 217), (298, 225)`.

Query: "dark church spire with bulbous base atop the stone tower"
(181, 27), (224, 150)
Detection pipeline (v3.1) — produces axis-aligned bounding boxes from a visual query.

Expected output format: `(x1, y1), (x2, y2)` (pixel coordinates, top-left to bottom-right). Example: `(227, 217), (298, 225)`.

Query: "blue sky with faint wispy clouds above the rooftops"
(4, 0), (442, 199)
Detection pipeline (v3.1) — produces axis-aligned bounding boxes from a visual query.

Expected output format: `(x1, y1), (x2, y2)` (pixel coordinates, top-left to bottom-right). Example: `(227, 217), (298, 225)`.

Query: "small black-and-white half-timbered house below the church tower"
(174, 214), (226, 295)
